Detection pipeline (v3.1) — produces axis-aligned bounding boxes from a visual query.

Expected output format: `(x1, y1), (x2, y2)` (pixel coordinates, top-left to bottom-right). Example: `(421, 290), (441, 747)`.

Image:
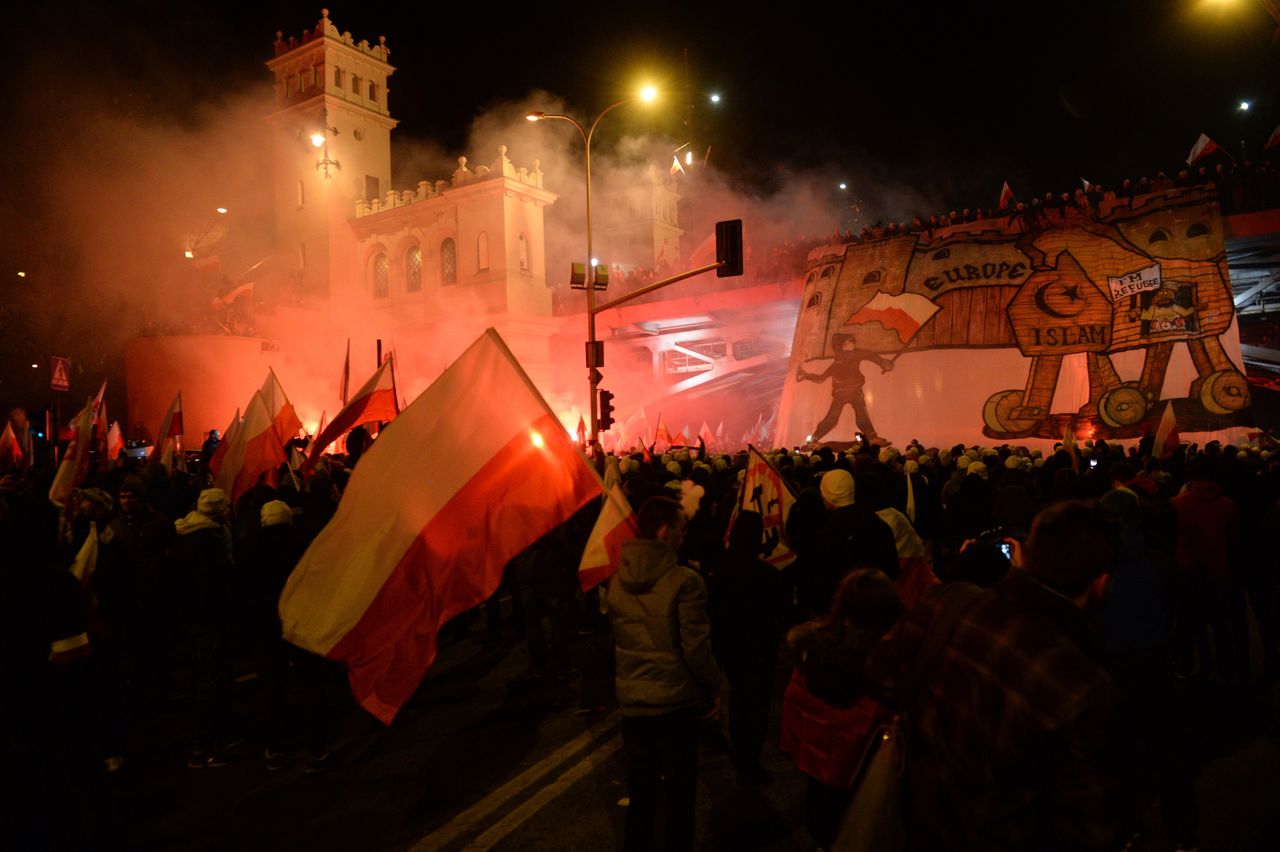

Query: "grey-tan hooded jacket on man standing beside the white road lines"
(605, 539), (721, 716)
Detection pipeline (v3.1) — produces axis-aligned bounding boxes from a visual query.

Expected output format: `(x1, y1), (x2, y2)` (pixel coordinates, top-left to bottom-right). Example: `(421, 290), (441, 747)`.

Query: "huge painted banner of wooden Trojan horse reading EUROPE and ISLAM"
(778, 188), (1251, 446)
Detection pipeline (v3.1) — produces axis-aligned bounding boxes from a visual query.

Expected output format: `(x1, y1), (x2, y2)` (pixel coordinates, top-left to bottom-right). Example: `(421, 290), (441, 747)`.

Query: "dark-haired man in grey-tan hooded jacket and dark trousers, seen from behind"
(605, 496), (721, 851)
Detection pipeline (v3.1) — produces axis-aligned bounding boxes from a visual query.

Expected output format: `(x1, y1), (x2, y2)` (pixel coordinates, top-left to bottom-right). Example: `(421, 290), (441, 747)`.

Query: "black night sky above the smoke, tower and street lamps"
(10, 0), (1280, 206)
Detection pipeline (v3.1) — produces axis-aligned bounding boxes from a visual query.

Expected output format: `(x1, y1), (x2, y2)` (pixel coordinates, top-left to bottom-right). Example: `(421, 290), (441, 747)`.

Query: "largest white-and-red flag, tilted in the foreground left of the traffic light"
(279, 329), (602, 723)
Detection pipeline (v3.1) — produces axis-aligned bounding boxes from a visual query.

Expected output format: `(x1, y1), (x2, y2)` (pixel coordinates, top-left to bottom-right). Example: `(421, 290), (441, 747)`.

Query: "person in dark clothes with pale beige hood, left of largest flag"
(173, 489), (233, 769)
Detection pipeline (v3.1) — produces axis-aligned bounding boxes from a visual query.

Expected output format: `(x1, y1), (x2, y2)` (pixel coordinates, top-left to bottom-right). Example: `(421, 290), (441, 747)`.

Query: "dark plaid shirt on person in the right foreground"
(870, 573), (1124, 851)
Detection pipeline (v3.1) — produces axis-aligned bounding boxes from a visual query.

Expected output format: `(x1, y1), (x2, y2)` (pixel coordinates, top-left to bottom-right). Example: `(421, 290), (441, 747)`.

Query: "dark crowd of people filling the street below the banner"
(0, 417), (1280, 849)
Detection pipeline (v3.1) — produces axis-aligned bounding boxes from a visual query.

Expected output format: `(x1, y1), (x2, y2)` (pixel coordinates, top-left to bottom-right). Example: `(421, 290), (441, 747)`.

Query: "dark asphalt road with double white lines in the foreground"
(37, 596), (1280, 852)
